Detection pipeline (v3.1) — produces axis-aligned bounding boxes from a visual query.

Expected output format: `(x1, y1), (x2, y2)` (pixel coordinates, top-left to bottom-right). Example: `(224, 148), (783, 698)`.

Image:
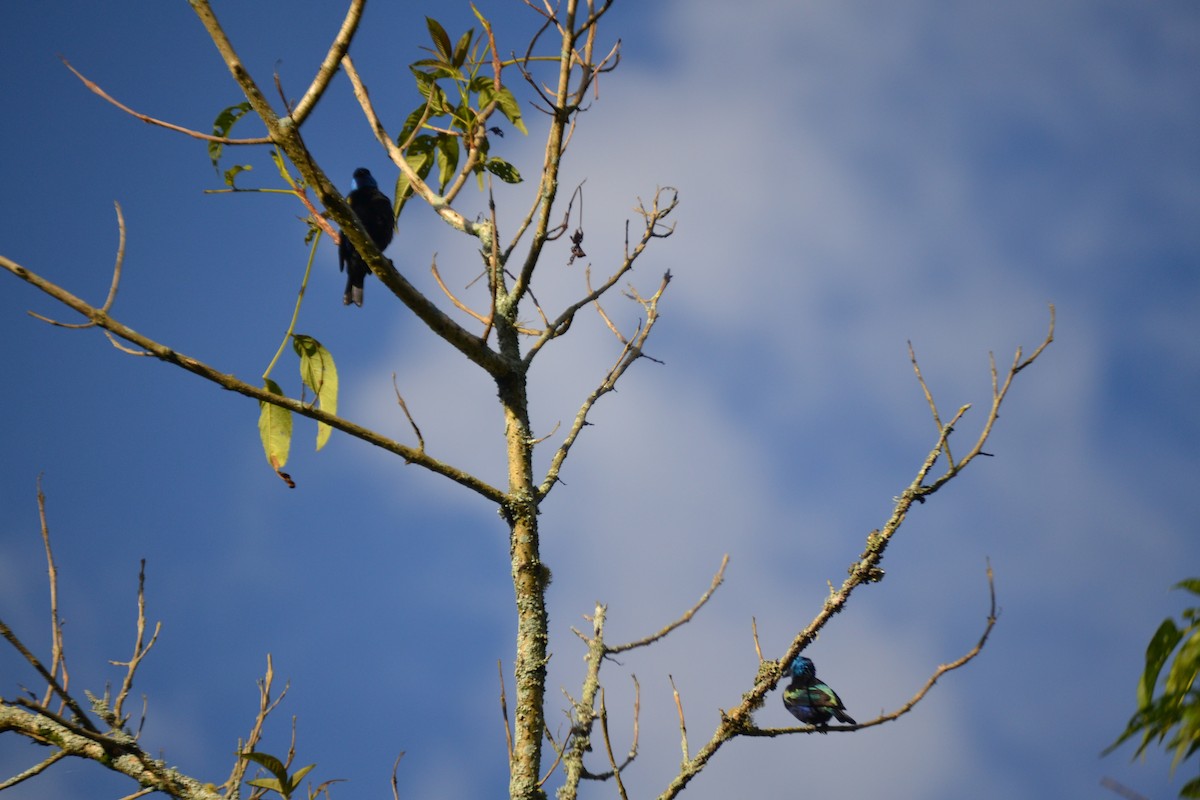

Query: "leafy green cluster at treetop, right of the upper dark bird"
(396, 14), (529, 217)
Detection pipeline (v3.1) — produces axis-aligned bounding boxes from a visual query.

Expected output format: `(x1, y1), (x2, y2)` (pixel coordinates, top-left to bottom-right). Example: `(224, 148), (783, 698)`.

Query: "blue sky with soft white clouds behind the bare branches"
(0, 0), (1200, 800)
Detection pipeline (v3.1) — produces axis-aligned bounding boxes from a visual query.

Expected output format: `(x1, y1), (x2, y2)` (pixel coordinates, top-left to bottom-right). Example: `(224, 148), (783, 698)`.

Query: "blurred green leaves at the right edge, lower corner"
(1104, 578), (1200, 798)
